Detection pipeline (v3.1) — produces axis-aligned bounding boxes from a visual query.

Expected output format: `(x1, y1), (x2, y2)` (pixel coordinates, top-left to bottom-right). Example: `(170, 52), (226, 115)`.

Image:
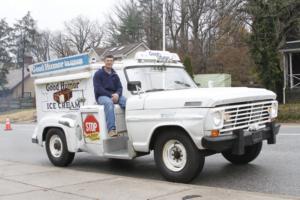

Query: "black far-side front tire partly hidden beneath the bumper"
(222, 142), (262, 165)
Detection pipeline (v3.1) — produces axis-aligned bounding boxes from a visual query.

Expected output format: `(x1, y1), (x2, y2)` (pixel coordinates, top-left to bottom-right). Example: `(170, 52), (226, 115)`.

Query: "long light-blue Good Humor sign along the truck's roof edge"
(32, 54), (89, 74)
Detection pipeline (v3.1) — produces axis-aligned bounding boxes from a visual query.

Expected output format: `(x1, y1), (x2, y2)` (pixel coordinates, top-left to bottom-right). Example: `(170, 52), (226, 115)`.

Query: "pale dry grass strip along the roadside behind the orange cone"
(0, 109), (36, 123)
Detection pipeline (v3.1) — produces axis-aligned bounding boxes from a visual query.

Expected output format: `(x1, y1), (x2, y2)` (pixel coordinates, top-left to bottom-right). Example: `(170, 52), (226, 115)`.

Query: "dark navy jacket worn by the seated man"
(93, 67), (123, 101)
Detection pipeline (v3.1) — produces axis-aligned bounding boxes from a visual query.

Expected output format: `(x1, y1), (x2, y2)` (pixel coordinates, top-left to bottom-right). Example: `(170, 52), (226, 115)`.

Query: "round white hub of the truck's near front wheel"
(163, 140), (187, 172)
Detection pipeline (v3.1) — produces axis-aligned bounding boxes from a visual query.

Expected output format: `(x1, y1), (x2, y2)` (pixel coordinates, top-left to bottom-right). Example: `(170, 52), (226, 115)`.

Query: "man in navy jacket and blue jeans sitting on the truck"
(93, 55), (126, 137)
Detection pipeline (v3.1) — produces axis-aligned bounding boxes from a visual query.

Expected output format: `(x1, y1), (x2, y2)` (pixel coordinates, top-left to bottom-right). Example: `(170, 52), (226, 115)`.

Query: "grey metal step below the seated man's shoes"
(103, 136), (136, 160)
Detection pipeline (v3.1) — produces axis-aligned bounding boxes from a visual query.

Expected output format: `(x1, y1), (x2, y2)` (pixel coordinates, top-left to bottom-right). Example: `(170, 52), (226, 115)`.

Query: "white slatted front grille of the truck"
(220, 101), (272, 134)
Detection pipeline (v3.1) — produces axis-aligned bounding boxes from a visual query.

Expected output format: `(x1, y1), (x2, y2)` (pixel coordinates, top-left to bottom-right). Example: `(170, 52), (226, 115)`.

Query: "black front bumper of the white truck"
(202, 122), (280, 155)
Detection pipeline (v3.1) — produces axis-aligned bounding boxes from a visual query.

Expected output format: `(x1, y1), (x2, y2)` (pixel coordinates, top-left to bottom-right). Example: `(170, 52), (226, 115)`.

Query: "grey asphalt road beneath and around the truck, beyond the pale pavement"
(0, 124), (300, 196)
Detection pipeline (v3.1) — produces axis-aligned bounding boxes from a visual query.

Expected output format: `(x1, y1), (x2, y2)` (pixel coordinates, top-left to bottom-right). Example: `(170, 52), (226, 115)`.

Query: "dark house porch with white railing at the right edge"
(280, 40), (300, 103)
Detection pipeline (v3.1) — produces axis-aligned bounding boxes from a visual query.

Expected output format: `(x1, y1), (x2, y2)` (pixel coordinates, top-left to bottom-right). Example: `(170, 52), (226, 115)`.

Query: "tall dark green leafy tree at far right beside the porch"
(247, 0), (300, 100)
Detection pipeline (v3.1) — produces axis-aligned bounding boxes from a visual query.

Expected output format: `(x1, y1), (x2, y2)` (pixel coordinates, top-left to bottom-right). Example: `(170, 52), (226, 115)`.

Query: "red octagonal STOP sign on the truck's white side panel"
(83, 114), (100, 140)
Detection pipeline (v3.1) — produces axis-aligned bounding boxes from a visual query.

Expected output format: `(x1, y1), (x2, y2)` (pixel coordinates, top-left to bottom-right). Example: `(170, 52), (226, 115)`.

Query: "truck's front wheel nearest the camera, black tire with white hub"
(154, 129), (205, 183)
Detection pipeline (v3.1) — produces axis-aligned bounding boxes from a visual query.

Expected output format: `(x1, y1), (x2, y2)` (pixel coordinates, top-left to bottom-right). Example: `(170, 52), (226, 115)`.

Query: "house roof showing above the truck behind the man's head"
(95, 42), (150, 60)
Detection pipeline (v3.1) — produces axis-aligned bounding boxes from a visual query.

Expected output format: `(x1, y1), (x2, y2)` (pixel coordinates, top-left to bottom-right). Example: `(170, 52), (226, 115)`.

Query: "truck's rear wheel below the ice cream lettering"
(46, 128), (75, 167)
